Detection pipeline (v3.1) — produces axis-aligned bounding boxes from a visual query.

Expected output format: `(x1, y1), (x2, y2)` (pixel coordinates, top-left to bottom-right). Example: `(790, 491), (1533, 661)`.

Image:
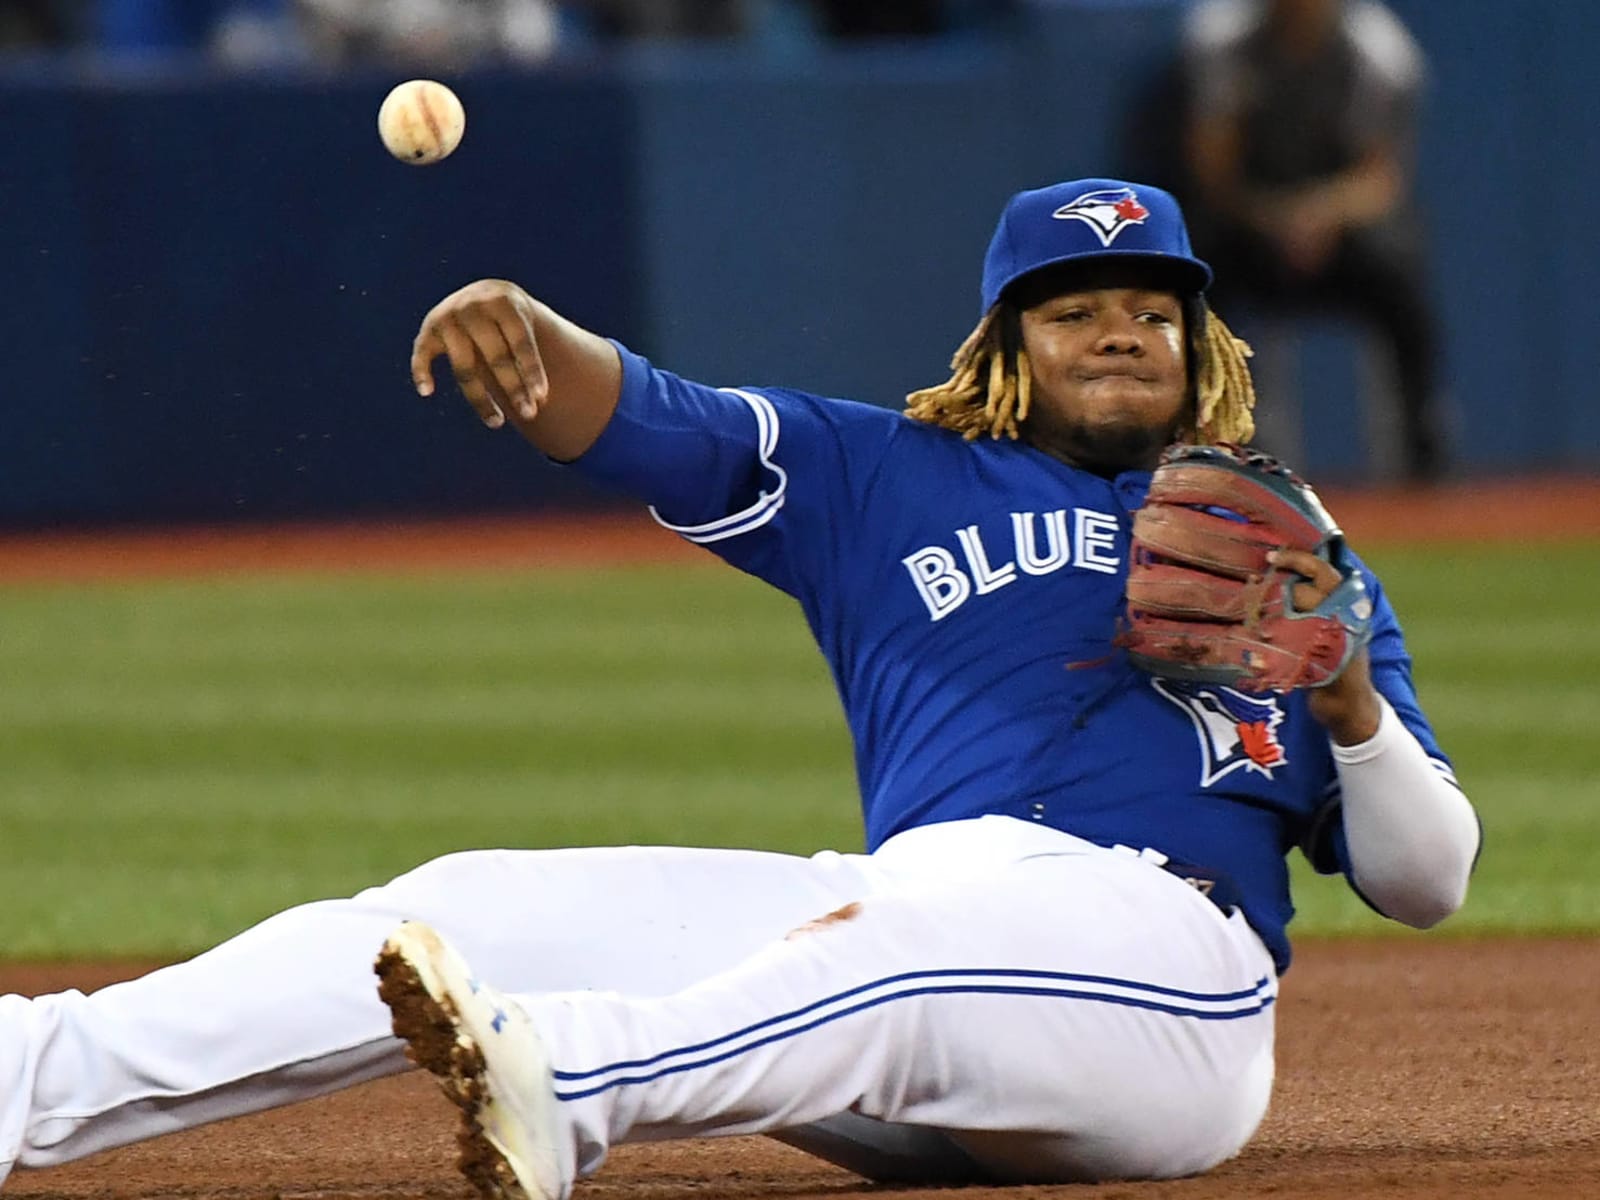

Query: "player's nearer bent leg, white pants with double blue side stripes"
(499, 819), (1275, 1181)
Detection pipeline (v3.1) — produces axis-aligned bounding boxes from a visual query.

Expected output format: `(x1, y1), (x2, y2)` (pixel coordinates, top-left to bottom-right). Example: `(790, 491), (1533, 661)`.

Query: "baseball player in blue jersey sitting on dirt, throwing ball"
(0, 179), (1480, 1197)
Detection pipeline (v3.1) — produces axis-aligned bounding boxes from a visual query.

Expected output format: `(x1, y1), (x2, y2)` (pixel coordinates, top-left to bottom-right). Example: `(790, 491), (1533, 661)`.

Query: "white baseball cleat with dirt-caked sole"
(373, 922), (568, 1200)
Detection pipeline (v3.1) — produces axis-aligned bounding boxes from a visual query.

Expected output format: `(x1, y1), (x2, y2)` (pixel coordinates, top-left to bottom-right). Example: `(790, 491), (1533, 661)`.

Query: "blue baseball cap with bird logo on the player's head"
(982, 179), (1211, 312)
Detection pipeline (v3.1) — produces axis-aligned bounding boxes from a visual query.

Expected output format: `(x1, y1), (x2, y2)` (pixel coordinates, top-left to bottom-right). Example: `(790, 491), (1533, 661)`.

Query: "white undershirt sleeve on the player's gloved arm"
(1333, 696), (1482, 930)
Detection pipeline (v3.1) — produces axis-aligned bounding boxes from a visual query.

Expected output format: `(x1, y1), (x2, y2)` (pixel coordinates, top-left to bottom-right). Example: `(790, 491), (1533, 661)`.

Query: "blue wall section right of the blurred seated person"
(1392, 0), (1600, 469)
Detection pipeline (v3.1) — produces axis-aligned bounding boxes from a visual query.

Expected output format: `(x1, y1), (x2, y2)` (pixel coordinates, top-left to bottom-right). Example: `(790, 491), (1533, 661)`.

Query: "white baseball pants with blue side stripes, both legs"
(0, 816), (1277, 1182)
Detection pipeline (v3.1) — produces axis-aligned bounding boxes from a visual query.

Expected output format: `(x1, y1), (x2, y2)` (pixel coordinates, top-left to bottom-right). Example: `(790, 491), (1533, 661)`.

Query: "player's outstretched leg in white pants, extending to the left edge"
(0, 848), (870, 1179)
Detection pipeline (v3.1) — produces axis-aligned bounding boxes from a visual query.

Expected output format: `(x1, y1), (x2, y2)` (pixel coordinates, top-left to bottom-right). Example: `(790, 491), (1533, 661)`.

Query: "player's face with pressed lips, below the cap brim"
(1022, 286), (1189, 474)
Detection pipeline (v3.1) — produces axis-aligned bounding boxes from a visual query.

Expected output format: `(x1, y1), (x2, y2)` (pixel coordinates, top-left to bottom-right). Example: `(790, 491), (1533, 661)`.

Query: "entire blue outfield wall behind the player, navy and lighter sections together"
(0, 0), (1600, 528)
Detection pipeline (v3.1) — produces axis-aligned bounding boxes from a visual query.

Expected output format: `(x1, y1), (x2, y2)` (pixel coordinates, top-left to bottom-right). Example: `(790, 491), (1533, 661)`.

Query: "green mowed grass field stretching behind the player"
(0, 544), (1600, 958)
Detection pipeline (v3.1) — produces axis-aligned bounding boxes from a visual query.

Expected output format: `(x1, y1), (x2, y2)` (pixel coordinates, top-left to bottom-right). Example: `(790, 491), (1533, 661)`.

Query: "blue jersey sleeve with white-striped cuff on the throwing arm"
(571, 342), (901, 600)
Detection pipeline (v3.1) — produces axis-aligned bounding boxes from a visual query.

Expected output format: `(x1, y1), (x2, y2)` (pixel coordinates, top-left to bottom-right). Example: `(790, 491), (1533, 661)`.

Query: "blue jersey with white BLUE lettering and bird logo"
(574, 347), (1450, 970)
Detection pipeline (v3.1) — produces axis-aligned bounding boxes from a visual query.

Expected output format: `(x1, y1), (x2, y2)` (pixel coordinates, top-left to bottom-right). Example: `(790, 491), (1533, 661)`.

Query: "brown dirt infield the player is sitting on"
(0, 936), (1600, 1200)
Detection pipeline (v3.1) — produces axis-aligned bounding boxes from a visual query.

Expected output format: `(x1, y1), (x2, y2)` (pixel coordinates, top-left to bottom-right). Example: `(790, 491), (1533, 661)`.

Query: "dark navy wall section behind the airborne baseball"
(0, 64), (642, 528)
